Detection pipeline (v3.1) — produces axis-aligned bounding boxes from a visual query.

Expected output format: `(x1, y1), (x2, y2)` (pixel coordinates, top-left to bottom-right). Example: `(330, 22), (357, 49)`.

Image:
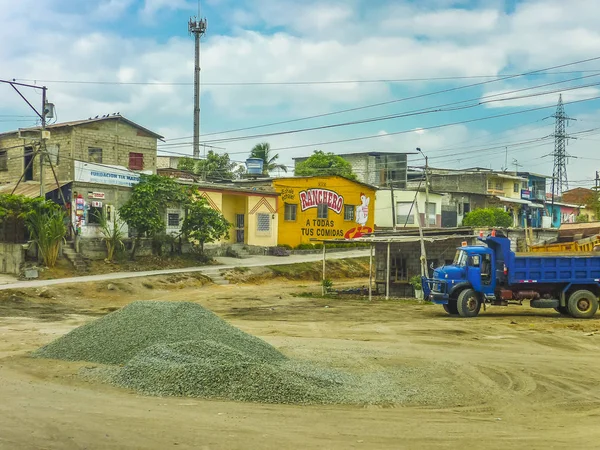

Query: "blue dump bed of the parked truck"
(508, 252), (600, 284)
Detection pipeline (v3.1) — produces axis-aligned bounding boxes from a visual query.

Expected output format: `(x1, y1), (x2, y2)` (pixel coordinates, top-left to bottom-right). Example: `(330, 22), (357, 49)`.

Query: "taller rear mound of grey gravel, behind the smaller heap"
(33, 302), (285, 365)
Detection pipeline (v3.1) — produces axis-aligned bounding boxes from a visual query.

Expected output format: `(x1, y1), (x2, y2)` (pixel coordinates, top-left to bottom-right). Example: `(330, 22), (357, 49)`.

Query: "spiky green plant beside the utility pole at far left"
(25, 204), (67, 267)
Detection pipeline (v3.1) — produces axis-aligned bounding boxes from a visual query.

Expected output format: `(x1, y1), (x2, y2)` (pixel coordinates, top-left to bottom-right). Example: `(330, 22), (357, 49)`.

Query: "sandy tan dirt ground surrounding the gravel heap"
(0, 275), (600, 449)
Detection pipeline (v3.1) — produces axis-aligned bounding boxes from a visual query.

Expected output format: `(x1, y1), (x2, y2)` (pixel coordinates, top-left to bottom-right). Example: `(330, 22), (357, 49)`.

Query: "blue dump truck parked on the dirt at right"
(422, 232), (600, 319)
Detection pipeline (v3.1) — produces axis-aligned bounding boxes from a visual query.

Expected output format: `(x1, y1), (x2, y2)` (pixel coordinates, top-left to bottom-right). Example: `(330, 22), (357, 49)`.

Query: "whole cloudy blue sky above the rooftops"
(0, 0), (600, 186)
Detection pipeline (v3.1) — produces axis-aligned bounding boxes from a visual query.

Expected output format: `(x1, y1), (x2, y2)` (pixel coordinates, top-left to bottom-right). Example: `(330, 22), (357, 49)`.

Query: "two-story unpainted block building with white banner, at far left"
(0, 114), (162, 237)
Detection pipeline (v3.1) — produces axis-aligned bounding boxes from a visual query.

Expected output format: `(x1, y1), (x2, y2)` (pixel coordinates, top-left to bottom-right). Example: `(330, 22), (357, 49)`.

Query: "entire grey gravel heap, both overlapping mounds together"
(33, 302), (408, 404)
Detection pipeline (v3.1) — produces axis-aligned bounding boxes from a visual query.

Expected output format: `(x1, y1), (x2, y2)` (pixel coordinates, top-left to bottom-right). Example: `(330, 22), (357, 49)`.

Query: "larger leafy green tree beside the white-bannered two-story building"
(119, 174), (188, 259)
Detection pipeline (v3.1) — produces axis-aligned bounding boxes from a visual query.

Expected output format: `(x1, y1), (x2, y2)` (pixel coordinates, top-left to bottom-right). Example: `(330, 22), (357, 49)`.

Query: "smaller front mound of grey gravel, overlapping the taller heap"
(107, 340), (347, 403)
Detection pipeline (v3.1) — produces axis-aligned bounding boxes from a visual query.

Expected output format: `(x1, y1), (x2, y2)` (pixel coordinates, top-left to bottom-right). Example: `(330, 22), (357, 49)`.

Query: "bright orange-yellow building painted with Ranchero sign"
(262, 176), (375, 247)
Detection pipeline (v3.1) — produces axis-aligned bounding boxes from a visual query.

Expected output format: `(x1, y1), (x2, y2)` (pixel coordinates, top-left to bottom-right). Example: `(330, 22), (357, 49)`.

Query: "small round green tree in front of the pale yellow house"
(181, 197), (231, 255)
